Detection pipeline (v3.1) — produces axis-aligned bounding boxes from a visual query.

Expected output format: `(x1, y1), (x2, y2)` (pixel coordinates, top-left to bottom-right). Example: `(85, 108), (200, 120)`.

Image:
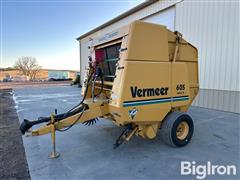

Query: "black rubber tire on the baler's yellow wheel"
(160, 111), (194, 147)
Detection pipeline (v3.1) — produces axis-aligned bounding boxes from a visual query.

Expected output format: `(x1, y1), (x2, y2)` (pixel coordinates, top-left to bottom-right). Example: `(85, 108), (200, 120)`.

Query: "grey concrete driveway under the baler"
(14, 86), (240, 179)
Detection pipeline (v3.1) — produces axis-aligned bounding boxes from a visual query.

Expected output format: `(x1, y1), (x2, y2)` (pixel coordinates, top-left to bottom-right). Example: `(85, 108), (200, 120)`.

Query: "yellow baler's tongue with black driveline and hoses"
(19, 99), (108, 136)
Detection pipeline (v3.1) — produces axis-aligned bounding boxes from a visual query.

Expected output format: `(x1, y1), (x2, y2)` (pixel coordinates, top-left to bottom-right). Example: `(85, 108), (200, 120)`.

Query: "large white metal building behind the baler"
(77, 0), (240, 113)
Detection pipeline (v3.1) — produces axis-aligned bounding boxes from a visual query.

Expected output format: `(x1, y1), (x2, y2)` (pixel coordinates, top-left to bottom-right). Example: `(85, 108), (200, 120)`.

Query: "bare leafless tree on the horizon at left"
(14, 56), (41, 81)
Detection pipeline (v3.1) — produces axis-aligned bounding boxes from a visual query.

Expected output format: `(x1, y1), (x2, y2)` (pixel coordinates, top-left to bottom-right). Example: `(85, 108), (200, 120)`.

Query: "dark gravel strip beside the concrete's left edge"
(0, 89), (30, 179)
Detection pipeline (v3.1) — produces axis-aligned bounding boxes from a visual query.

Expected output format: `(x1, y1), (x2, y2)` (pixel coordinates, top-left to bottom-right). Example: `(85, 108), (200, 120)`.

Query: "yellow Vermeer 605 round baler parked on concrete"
(20, 21), (199, 153)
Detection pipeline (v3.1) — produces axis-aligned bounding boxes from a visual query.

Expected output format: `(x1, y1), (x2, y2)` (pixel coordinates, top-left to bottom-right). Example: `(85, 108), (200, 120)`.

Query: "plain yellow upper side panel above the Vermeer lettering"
(127, 21), (168, 61)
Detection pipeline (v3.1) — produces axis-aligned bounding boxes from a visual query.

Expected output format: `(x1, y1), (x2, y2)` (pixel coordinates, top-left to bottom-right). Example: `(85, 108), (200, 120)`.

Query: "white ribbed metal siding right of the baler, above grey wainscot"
(175, 0), (239, 91)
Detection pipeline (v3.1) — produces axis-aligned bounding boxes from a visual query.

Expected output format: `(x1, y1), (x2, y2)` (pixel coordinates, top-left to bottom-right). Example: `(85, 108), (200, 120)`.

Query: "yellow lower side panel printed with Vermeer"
(110, 60), (171, 122)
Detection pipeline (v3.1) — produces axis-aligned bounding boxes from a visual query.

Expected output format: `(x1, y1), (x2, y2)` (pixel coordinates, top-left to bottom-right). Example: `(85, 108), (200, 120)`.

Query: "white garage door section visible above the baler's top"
(143, 6), (175, 31)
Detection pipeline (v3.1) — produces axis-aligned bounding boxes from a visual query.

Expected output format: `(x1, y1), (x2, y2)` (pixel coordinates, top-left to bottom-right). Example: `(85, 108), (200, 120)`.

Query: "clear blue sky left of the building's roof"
(0, 0), (142, 70)
